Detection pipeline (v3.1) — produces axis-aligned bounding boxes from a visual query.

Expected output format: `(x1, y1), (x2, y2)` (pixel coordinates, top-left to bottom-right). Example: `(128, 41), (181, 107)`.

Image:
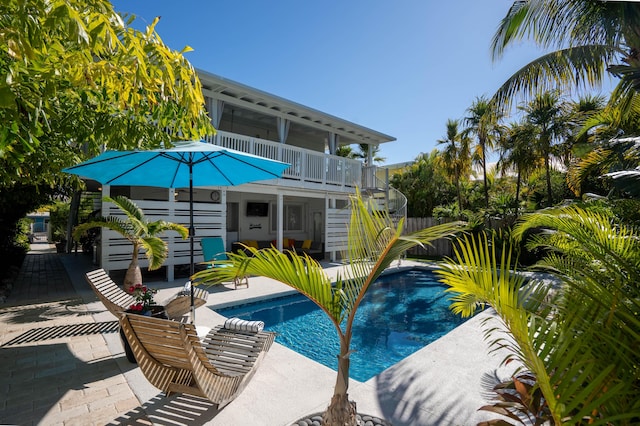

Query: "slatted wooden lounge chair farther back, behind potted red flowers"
(85, 269), (209, 319)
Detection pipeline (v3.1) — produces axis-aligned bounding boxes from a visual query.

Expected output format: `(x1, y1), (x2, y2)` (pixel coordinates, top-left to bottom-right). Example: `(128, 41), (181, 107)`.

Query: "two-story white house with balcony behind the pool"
(97, 71), (406, 280)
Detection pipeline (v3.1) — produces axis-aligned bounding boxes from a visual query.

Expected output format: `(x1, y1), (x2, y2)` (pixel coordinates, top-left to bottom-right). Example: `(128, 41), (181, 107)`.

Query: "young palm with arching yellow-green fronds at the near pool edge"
(193, 193), (461, 426)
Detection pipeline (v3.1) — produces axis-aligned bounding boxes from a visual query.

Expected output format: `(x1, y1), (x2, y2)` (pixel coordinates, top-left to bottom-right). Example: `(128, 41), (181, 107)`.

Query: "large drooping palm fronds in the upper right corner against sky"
(491, 0), (640, 111)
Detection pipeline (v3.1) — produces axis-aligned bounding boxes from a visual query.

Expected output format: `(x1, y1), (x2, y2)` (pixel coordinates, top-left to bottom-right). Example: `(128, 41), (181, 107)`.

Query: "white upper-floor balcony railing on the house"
(206, 131), (362, 190)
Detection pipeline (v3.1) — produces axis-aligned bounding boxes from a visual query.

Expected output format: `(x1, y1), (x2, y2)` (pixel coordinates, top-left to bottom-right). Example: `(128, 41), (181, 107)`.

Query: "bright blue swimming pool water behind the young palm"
(217, 269), (464, 382)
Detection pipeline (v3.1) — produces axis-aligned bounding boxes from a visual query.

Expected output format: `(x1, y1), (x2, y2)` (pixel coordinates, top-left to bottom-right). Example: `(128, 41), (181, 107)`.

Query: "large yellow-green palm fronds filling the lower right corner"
(438, 206), (640, 425)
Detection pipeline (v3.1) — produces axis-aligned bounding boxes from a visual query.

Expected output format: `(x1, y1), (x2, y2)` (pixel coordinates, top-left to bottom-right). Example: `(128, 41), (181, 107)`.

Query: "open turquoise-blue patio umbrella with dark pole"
(62, 141), (289, 321)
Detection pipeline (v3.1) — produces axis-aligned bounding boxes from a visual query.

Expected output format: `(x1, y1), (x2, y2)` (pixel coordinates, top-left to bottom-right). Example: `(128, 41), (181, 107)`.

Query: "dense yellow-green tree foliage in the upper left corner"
(0, 0), (213, 187)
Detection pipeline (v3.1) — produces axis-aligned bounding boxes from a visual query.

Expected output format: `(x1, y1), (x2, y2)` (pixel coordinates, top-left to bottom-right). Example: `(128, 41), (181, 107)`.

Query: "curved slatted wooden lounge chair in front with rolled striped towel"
(120, 314), (275, 408)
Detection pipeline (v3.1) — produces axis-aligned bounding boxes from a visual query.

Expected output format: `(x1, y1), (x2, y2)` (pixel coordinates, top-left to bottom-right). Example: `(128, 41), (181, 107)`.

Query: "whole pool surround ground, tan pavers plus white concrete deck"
(0, 246), (510, 426)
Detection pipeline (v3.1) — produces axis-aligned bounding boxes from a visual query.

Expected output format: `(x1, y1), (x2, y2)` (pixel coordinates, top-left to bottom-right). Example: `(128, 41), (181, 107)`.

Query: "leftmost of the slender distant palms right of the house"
(437, 119), (471, 212)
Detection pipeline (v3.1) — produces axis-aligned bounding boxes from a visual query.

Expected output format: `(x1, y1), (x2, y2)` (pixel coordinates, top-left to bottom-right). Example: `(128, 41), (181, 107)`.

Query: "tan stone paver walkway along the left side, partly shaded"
(0, 245), (151, 425)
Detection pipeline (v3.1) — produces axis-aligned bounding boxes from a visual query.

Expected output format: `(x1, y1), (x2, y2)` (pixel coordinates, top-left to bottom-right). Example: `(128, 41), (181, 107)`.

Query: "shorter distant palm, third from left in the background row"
(498, 123), (538, 217)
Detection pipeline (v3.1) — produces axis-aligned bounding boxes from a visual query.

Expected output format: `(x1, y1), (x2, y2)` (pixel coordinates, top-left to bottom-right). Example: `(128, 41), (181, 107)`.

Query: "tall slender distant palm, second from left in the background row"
(464, 96), (502, 208)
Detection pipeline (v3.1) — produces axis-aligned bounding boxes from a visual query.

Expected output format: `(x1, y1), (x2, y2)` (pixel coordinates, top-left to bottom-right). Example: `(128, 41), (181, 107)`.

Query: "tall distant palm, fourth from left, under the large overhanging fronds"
(519, 92), (568, 207)
